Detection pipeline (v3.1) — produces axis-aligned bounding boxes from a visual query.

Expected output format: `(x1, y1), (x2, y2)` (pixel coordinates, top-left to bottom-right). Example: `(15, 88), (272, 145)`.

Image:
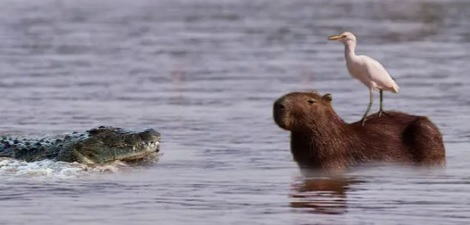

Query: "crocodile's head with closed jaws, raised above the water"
(56, 126), (160, 164)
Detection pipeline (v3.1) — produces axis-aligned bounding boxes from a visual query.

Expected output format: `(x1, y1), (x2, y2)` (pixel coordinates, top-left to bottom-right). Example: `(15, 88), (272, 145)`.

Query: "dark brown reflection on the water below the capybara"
(290, 177), (359, 214)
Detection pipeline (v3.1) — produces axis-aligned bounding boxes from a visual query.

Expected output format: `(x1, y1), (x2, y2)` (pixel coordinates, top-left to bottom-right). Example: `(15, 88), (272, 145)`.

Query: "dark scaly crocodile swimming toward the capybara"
(0, 126), (160, 164)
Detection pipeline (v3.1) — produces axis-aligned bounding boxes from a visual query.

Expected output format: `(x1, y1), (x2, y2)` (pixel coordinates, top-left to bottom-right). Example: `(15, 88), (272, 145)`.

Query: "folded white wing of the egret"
(361, 56), (399, 93)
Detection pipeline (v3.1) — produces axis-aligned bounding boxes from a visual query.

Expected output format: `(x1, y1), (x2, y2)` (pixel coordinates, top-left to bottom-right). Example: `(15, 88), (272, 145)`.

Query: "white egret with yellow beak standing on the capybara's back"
(328, 32), (400, 125)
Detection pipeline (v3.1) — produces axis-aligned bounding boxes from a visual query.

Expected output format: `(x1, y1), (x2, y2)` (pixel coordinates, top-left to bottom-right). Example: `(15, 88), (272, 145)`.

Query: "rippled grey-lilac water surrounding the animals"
(0, 0), (470, 225)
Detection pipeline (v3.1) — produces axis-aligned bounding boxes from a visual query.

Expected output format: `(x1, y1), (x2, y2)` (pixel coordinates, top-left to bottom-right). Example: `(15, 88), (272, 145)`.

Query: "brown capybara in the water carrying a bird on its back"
(273, 92), (445, 172)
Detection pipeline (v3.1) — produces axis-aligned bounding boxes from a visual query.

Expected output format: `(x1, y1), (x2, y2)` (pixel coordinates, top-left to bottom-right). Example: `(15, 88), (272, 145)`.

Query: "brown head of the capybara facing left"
(273, 92), (335, 131)
